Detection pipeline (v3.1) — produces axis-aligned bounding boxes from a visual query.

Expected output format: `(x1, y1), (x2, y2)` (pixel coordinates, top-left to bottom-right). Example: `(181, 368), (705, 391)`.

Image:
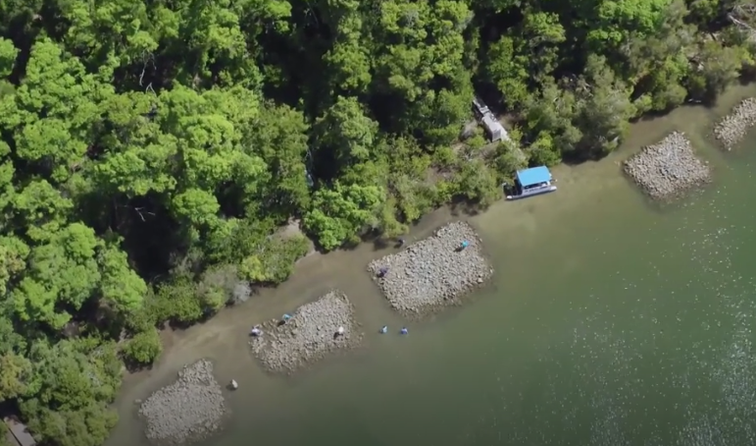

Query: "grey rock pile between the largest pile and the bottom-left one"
(250, 291), (364, 374)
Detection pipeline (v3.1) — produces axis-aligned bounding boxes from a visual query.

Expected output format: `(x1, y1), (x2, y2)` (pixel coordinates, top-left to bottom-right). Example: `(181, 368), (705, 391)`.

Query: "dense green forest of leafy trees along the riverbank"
(0, 0), (756, 446)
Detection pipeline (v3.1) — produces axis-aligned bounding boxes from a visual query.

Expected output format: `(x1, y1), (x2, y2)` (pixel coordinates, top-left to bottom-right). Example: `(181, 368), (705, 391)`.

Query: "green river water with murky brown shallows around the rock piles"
(111, 88), (756, 446)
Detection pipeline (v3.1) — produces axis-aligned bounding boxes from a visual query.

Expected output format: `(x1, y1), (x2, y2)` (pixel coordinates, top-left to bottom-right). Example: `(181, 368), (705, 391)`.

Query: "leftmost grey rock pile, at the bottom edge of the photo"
(139, 359), (226, 445)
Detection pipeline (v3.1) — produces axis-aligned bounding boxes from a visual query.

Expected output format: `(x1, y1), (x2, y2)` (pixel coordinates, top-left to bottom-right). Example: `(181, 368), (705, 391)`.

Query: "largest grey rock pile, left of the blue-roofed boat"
(367, 222), (493, 317)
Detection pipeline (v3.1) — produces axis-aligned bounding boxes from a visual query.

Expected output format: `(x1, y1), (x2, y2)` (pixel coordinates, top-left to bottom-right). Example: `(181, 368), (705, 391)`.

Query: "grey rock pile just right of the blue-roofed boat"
(623, 132), (711, 201)
